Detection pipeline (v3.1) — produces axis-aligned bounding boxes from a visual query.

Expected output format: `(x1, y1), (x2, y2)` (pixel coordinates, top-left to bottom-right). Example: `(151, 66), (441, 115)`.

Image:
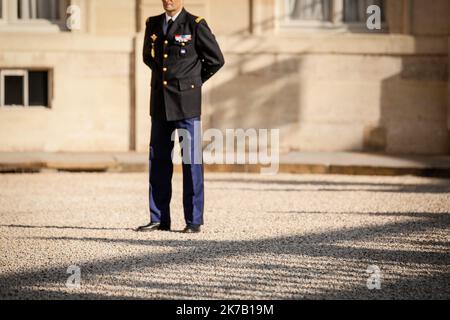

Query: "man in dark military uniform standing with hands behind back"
(136, 0), (224, 233)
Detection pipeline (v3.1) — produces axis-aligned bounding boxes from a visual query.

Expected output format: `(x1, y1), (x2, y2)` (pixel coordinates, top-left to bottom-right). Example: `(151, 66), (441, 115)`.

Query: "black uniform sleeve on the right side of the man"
(196, 20), (225, 82)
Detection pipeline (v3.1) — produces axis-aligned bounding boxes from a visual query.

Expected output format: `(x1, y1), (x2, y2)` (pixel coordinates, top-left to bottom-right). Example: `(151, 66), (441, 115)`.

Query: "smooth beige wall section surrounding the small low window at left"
(0, 36), (133, 151)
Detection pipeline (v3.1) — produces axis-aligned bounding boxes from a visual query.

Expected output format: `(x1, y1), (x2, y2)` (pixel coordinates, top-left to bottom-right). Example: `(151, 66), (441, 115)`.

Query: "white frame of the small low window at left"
(0, 68), (53, 110)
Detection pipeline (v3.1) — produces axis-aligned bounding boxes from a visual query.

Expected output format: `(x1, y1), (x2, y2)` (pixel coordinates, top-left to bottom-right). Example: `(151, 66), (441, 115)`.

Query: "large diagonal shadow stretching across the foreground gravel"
(0, 212), (450, 299)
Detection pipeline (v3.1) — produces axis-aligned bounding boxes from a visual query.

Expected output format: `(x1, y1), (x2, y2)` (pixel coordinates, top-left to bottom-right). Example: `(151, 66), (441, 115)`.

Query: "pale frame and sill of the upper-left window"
(0, 0), (71, 32)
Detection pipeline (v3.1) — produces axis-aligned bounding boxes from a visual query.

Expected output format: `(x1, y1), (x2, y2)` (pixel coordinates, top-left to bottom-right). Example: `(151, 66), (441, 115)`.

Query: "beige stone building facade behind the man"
(0, 0), (450, 154)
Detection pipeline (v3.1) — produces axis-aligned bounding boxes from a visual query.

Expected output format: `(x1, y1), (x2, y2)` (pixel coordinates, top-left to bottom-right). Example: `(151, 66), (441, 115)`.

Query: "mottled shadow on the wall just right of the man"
(209, 54), (301, 129)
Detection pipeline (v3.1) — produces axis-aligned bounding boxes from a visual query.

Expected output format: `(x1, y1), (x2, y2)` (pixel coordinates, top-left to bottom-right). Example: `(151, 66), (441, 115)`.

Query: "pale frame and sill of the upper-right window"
(276, 0), (388, 33)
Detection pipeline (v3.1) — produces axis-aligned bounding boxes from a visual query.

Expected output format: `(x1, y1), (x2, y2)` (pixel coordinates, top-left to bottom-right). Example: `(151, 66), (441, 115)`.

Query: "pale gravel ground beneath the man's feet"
(0, 173), (450, 299)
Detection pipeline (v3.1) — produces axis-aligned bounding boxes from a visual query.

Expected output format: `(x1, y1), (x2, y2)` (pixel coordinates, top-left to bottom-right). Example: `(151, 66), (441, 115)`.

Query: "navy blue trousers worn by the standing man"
(149, 117), (204, 225)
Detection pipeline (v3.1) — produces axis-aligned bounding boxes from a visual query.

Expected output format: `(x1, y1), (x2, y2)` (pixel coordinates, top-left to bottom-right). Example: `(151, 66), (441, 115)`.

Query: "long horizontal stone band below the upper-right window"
(218, 33), (448, 55)
